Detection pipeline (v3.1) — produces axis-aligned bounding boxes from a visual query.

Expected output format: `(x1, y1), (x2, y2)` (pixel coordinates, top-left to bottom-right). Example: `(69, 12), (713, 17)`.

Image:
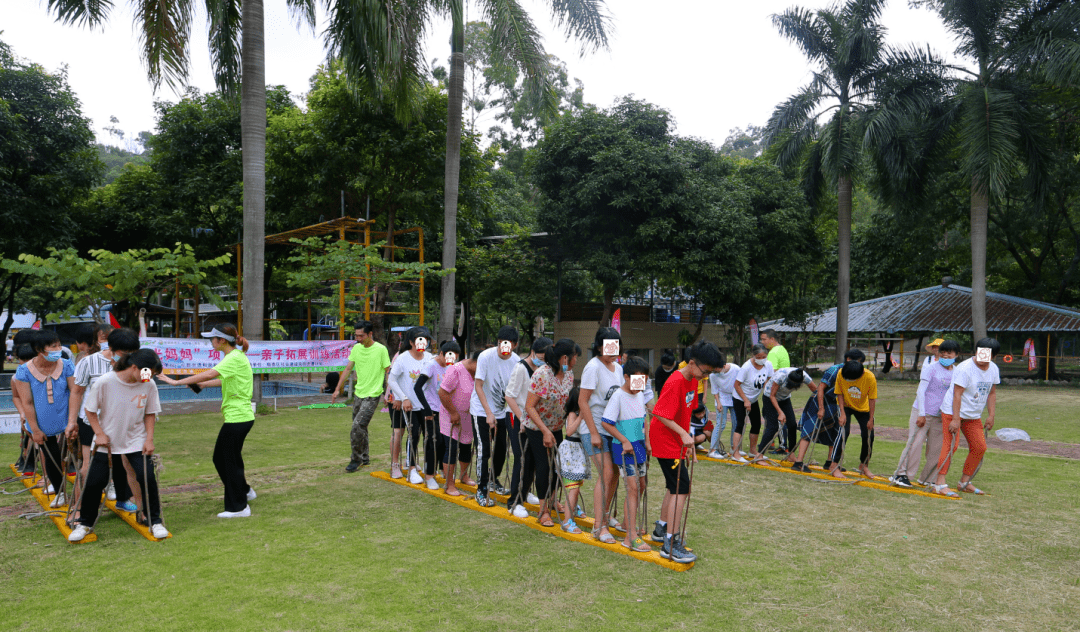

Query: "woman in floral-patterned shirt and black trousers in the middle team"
(525, 338), (581, 527)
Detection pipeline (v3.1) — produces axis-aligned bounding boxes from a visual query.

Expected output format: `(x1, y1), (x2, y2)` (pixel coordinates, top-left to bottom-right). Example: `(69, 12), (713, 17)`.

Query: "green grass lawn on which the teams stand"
(0, 384), (1080, 632)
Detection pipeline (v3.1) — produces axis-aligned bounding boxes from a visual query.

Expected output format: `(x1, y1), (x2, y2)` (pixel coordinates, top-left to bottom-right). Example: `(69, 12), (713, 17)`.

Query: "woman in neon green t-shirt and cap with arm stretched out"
(158, 325), (255, 517)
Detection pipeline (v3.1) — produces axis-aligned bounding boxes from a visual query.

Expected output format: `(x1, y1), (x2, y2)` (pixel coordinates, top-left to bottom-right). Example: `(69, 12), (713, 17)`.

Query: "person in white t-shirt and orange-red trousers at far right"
(933, 338), (1001, 497)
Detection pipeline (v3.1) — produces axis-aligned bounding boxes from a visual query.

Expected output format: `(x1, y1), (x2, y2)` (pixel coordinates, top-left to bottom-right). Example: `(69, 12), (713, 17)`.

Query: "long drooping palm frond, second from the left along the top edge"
(135, 0), (194, 90)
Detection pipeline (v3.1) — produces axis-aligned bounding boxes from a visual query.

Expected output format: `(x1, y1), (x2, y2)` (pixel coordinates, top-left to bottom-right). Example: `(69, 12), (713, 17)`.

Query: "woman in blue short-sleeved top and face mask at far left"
(11, 330), (79, 508)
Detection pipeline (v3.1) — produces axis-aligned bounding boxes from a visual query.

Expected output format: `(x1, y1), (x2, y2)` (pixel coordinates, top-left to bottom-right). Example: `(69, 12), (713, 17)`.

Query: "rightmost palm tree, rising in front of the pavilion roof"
(918, 0), (1080, 340)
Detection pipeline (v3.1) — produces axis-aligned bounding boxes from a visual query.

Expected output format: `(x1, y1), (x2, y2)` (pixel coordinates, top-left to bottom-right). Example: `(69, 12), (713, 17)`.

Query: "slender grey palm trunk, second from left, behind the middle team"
(437, 14), (465, 347)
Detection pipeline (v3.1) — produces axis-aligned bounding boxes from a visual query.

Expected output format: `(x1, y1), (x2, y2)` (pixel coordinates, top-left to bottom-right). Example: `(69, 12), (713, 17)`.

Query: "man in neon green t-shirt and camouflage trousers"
(330, 320), (390, 472)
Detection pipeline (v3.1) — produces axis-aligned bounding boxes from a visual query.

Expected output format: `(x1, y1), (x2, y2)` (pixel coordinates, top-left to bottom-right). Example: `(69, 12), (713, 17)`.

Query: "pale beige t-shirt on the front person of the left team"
(83, 371), (161, 454)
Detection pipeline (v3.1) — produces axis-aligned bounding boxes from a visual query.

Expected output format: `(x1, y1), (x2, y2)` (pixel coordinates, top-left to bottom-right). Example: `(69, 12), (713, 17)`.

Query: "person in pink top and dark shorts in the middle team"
(438, 351), (481, 496)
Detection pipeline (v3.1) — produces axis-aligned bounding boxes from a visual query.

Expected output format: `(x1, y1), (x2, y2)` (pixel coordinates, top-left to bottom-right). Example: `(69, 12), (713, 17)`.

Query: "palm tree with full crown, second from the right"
(765, 0), (885, 362)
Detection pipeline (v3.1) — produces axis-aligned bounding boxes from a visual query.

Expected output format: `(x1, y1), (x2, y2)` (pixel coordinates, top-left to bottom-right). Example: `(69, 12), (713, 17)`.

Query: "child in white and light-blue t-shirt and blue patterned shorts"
(600, 355), (651, 552)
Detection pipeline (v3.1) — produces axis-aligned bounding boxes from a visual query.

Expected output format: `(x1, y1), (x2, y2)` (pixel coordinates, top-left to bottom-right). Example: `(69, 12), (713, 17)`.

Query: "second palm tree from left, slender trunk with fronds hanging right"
(431, 0), (610, 340)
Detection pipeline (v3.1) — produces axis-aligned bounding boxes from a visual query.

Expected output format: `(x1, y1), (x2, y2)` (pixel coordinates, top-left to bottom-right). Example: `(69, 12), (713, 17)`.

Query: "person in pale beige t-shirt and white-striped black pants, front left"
(68, 349), (168, 542)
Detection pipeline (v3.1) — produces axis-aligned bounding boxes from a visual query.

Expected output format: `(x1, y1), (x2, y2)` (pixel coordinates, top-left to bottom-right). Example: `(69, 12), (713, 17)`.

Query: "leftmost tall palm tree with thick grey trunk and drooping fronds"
(41, 0), (423, 350)
